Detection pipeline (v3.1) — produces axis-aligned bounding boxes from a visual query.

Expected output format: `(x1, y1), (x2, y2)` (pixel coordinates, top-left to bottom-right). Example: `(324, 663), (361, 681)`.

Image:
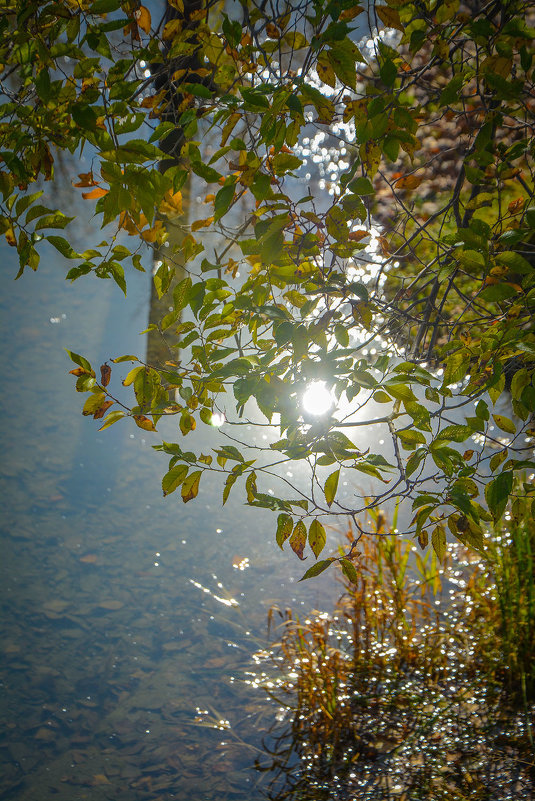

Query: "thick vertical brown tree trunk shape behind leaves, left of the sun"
(146, 0), (202, 366)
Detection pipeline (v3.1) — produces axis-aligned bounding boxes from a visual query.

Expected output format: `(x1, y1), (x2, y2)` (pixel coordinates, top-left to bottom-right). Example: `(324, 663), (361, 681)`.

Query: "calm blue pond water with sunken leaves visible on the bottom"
(0, 177), (344, 801)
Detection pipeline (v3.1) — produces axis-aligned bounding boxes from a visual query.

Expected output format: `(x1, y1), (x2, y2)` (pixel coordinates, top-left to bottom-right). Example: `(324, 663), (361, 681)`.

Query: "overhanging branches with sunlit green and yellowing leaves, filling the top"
(0, 0), (535, 577)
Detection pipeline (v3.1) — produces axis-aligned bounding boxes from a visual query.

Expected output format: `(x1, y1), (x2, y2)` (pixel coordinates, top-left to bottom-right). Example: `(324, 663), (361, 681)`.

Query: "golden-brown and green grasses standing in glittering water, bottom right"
(252, 496), (535, 801)
